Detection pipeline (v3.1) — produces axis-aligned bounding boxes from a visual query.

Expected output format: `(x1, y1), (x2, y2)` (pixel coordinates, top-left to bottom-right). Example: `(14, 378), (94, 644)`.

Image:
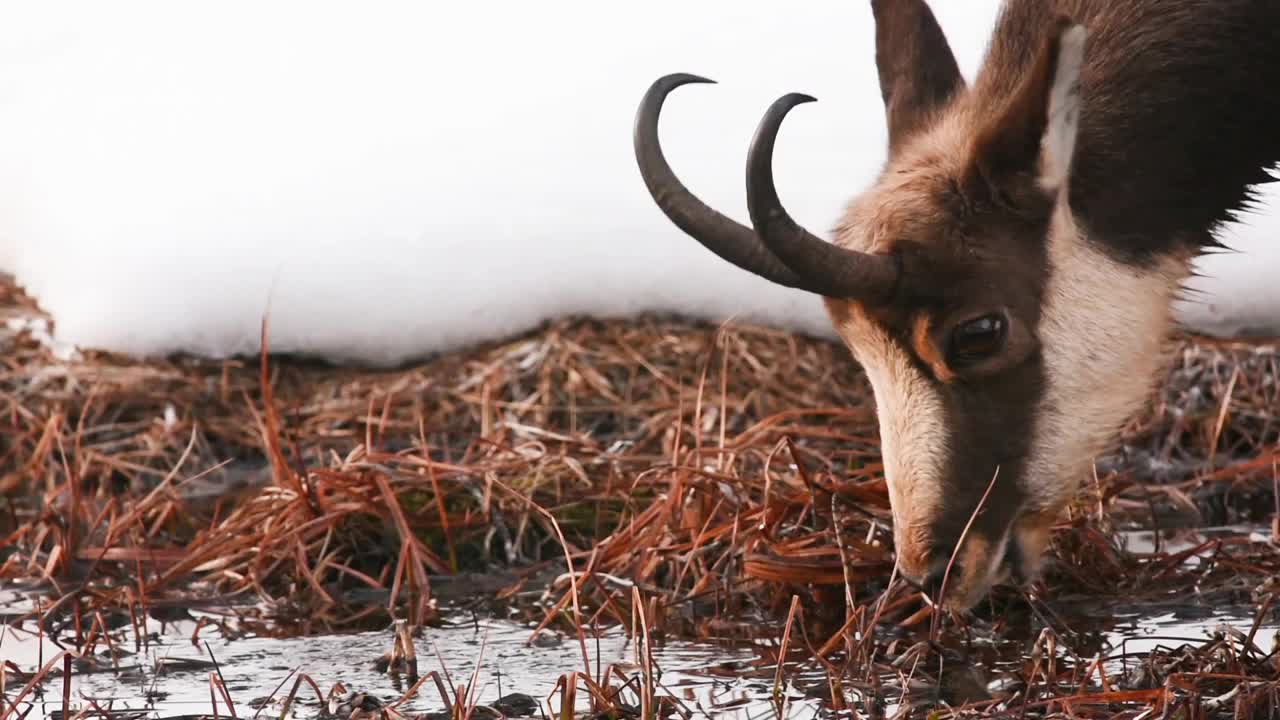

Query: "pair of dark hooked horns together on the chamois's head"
(635, 73), (899, 302)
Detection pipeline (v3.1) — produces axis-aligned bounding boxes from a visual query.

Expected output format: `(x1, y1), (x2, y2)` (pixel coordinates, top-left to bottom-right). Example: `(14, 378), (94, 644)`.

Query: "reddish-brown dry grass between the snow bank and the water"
(0, 272), (1280, 717)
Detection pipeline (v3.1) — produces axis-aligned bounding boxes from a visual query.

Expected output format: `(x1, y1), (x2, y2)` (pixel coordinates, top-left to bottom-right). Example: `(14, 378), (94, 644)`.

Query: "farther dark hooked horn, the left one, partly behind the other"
(635, 73), (812, 291)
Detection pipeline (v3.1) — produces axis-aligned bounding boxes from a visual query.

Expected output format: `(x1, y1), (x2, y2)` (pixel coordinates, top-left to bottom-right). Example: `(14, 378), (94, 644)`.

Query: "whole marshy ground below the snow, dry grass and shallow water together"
(0, 275), (1280, 717)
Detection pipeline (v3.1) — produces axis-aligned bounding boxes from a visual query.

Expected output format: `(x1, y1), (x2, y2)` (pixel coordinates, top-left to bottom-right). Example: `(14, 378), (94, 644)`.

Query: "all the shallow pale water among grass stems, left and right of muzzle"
(0, 586), (1280, 720)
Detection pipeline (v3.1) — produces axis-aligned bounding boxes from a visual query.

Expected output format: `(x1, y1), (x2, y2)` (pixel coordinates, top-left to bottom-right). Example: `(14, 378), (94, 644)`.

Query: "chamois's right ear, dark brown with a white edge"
(969, 18), (1085, 195)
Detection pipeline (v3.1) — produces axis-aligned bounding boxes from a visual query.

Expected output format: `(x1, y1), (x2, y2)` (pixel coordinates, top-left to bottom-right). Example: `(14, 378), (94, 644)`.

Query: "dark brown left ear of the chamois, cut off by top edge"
(872, 0), (965, 152)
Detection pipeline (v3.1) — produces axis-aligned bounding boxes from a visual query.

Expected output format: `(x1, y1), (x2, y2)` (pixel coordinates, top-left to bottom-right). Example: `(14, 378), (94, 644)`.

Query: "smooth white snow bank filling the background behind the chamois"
(0, 0), (1280, 364)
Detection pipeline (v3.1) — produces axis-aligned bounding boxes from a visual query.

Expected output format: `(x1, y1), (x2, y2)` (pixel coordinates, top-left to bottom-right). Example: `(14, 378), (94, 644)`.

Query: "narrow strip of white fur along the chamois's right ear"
(1039, 26), (1087, 192)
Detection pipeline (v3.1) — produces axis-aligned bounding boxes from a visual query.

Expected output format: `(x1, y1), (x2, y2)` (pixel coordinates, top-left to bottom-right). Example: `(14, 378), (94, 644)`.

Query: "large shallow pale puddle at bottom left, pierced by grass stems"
(0, 607), (823, 720)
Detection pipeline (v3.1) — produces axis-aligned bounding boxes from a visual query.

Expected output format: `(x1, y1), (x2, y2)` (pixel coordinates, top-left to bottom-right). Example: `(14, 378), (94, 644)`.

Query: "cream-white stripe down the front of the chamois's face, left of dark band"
(838, 309), (948, 570)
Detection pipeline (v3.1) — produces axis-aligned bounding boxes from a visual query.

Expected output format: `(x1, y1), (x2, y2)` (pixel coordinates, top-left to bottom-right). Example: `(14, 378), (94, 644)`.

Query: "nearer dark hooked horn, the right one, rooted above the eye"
(746, 92), (901, 302)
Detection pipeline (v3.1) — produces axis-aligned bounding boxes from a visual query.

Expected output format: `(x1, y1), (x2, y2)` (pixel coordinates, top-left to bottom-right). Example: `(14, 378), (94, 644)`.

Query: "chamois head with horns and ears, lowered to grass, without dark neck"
(635, 0), (1185, 610)
